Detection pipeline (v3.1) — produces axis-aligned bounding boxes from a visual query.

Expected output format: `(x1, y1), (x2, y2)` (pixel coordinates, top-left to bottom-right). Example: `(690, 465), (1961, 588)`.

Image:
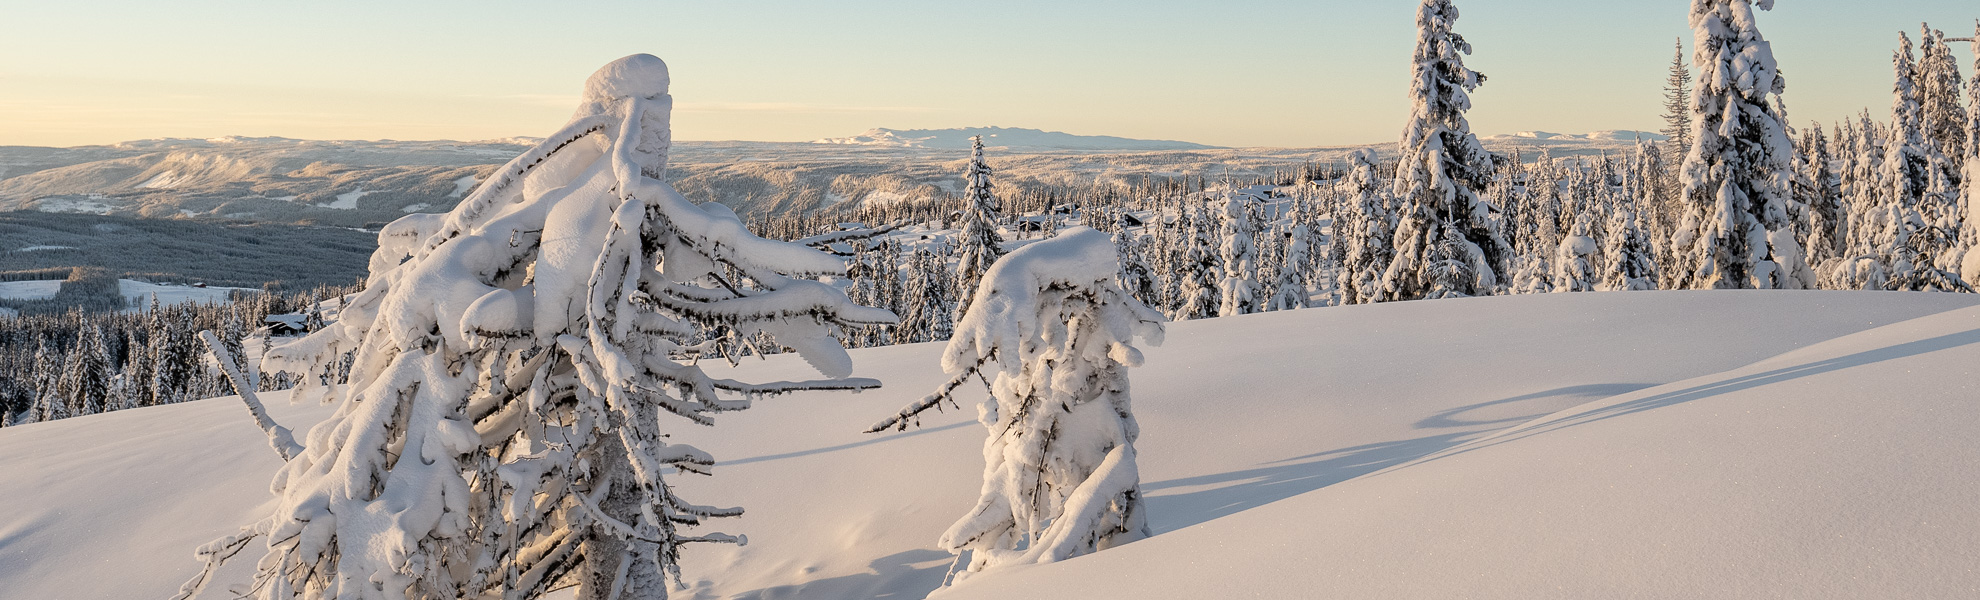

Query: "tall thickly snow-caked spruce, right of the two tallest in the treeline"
(1673, 0), (1800, 289)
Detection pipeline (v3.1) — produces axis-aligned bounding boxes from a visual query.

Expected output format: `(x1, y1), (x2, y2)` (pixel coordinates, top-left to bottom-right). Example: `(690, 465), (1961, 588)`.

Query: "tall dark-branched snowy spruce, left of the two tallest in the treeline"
(1376, 0), (1513, 301)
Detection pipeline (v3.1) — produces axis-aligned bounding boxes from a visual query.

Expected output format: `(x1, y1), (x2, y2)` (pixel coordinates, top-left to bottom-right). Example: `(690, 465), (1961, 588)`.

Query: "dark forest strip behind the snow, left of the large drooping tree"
(0, 281), (354, 426)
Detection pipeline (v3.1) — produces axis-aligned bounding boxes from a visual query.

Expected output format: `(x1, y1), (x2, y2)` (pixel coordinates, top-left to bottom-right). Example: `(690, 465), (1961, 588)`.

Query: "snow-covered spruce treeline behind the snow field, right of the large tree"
(758, 9), (1980, 352)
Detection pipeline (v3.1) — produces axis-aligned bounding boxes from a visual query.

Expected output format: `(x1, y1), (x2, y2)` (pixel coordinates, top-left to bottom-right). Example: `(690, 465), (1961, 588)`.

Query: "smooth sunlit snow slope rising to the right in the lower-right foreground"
(939, 299), (1980, 598)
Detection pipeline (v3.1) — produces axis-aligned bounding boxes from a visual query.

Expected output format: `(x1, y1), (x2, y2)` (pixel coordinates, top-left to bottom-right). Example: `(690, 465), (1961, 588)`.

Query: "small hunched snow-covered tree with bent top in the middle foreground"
(867, 228), (1162, 580)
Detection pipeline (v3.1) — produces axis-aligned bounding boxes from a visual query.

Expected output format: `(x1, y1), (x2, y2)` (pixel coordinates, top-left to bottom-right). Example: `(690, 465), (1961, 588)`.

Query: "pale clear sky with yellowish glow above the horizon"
(0, 0), (1980, 147)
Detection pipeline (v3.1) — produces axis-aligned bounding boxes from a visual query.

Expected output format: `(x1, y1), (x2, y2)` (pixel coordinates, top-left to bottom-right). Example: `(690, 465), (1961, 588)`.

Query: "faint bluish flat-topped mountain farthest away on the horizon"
(814, 127), (1216, 150)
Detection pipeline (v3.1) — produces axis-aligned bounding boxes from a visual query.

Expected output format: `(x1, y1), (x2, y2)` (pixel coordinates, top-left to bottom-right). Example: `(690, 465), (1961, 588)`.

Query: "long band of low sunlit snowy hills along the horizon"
(0, 127), (1663, 228)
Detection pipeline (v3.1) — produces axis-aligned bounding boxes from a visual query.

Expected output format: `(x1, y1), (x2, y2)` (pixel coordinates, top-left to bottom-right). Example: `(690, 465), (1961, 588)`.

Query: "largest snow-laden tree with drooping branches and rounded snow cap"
(182, 53), (893, 600)
